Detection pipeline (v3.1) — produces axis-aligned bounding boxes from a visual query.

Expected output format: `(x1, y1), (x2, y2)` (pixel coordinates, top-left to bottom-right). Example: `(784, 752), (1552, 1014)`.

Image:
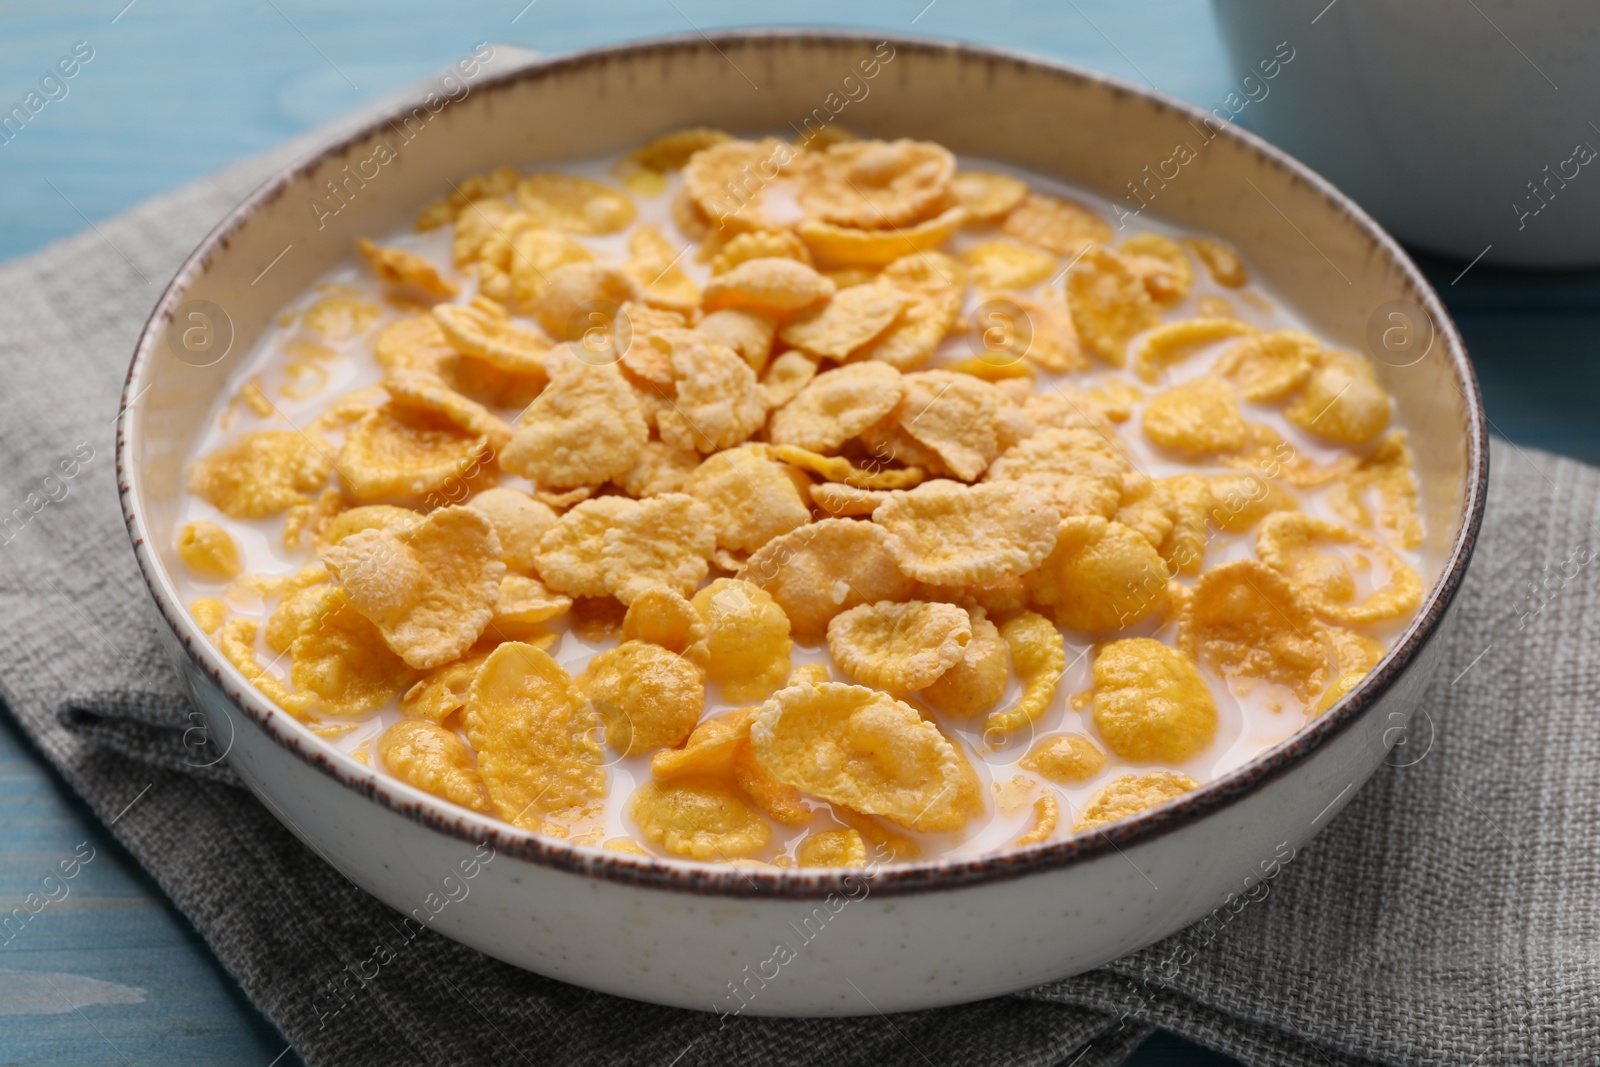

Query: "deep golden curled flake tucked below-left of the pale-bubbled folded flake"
(288, 585), (416, 715)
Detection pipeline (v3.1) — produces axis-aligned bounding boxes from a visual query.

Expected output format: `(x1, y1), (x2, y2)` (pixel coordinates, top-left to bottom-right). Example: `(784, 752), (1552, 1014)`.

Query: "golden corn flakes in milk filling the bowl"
(176, 130), (1422, 865)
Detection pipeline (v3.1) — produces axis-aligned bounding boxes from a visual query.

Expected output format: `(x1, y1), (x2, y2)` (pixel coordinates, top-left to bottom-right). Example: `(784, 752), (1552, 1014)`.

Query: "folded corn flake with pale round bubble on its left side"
(323, 507), (506, 669)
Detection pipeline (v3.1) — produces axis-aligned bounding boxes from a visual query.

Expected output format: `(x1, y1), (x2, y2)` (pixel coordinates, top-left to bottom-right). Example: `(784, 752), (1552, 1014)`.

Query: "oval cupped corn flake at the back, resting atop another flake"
(800, 139), (955, 229)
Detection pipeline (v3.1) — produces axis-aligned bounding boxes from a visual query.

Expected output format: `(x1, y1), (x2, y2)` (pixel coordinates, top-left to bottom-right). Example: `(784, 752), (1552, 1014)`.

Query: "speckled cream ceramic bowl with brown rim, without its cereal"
(117, 30), (1488, 1014)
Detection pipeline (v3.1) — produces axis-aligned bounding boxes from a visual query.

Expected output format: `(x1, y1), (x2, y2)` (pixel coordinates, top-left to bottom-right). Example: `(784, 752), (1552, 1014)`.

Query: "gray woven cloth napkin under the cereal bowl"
(0, 54), (1600, 1067)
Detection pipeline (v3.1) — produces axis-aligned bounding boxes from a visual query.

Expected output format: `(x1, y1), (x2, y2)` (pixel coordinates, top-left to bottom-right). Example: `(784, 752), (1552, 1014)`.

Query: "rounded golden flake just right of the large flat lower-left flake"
(578, 641), (706, 755)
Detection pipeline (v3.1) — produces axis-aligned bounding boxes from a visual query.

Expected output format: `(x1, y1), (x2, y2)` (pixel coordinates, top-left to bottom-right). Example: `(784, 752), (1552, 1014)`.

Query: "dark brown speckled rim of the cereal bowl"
(115, 27), (1490, 899)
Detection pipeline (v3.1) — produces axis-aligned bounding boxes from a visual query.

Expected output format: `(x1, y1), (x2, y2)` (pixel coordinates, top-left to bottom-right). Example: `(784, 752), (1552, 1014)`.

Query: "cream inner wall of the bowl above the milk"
(122, 32), (1486, 883)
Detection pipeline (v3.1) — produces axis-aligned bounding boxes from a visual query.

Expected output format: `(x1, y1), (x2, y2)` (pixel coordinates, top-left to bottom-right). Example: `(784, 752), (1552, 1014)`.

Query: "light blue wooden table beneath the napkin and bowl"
(0, 0), (1600, 1067)
